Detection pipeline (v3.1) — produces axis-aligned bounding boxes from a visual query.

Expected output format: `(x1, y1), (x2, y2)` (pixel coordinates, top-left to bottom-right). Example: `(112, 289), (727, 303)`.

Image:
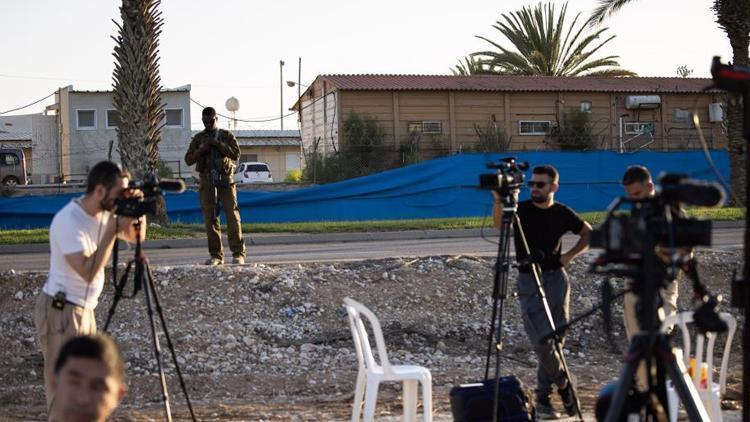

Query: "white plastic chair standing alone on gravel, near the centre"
(344, 298), (432, 422)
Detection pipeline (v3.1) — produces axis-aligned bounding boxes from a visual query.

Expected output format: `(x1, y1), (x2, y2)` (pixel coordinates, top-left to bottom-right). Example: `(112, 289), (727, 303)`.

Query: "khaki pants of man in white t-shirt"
(34, 292), (96, 413)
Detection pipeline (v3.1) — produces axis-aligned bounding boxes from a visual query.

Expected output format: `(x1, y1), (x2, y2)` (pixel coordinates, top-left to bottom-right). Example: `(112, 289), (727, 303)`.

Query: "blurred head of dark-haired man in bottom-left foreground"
(52, 334), (127, 421)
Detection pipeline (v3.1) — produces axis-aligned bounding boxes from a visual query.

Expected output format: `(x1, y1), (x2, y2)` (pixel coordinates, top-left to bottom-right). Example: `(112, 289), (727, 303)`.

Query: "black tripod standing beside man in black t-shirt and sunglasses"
(484, 188), (583, 421)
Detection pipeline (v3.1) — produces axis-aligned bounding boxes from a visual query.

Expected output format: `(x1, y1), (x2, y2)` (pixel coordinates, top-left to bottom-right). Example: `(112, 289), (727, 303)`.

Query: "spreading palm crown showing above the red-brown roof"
(464, 3), (635, 76)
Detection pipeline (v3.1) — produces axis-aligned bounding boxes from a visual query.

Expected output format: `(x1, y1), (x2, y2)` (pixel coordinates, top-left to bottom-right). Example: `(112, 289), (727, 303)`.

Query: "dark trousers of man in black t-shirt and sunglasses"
(518, 269), (570, 399)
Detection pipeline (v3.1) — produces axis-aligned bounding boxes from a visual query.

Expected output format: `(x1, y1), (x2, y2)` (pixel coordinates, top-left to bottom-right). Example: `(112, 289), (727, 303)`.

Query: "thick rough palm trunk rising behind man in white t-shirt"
(112, 0), (166, 219)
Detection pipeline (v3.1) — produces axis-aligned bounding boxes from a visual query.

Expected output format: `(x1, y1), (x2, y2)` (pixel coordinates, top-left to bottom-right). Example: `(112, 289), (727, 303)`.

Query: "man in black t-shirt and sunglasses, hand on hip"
(492, 165), (591, 419)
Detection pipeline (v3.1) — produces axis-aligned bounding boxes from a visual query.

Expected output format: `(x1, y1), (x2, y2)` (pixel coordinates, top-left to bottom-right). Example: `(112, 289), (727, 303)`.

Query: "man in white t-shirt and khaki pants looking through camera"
(34, 161), (146, 411)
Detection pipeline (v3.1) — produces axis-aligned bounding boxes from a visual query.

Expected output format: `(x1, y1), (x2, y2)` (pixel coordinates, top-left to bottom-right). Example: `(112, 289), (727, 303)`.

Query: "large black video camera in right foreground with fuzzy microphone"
(589, 174), (724, 263)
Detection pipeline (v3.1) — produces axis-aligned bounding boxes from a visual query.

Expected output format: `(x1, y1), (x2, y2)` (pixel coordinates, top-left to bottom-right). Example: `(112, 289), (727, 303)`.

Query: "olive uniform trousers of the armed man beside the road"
(200, 177), (245, 259)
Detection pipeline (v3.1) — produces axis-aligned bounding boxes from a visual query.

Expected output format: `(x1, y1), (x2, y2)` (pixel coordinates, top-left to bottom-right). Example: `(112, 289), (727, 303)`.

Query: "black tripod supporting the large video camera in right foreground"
(605, 235), (710, 422)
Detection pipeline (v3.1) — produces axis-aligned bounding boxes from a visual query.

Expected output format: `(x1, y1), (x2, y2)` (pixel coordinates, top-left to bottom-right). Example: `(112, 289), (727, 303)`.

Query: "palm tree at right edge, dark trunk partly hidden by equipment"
(590, 0), (750, 205)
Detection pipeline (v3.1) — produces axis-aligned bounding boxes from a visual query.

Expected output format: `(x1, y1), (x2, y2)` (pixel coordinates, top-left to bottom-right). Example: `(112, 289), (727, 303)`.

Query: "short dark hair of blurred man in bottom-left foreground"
(55, 334), (125, 381)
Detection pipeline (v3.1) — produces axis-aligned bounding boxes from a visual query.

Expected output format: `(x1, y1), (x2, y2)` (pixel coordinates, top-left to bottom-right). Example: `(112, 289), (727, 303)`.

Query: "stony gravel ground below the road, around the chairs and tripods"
(0, 249), (744, 420)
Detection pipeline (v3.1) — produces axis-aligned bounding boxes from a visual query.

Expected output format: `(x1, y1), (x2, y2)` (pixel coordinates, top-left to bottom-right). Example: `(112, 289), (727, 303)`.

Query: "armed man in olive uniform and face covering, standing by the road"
(185, 107), (245, 265)
